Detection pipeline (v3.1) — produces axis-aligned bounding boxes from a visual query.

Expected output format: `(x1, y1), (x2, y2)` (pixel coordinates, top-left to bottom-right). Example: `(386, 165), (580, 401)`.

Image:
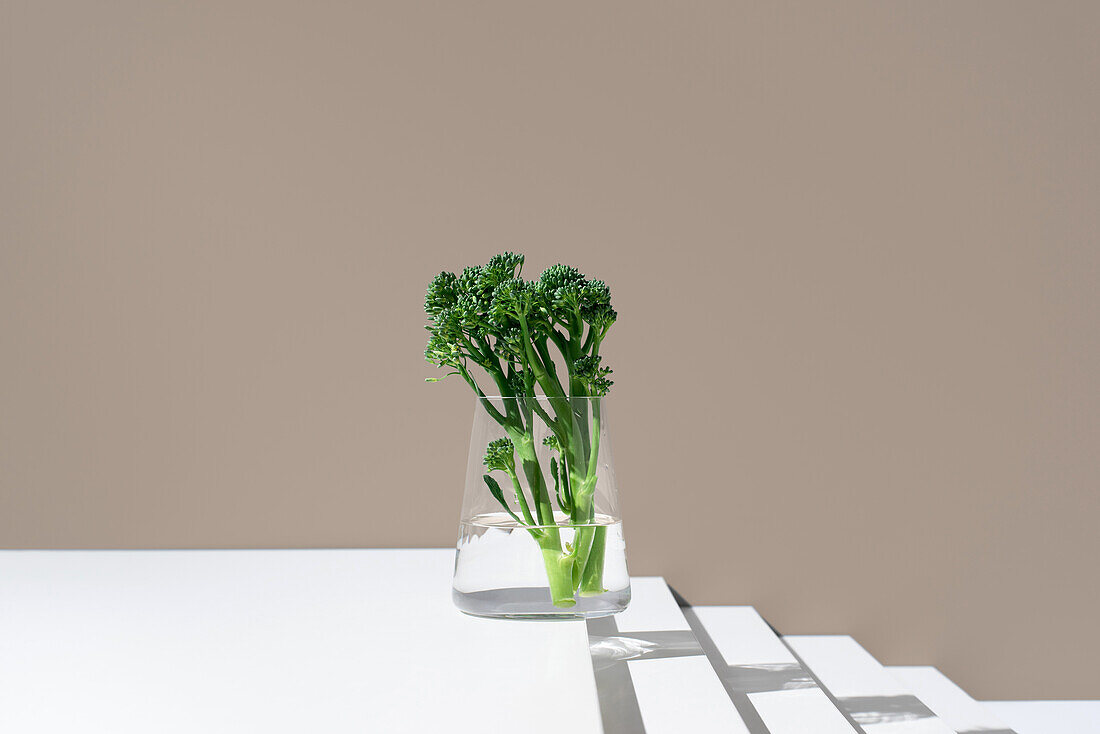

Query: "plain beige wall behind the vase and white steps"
(0, 1), (1100, 698)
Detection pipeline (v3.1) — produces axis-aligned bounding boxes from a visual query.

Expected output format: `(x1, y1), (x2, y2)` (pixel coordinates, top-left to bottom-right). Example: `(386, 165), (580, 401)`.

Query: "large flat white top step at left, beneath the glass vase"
(0, 550), (601, 734)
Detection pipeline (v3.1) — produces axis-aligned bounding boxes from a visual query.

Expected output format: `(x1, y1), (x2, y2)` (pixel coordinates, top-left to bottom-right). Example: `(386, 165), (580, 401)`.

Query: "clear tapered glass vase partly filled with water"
(452, 396), (630, 618)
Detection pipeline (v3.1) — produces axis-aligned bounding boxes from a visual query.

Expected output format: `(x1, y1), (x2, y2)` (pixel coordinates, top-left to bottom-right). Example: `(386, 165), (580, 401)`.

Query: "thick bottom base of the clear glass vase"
(451, 587), (630, 620)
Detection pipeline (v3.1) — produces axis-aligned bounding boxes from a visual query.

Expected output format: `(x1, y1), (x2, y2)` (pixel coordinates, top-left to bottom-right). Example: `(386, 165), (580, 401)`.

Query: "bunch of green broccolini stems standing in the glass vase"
(425, 252), (618, 607)
